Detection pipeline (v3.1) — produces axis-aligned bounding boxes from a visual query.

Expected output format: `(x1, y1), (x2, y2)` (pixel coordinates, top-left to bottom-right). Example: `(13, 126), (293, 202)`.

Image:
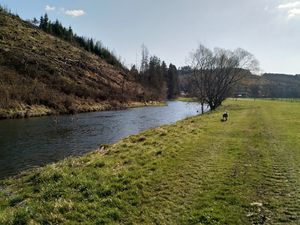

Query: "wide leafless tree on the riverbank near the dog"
(190, 45), (258, 112)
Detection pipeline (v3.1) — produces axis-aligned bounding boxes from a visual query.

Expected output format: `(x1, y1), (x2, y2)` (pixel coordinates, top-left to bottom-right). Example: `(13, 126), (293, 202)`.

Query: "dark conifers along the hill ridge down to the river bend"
(36, 14), (179, 99)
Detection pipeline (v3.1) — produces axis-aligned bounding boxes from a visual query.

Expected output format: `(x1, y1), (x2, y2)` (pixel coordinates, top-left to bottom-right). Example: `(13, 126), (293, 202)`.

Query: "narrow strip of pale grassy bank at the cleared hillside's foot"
(0, 101), (165, 120)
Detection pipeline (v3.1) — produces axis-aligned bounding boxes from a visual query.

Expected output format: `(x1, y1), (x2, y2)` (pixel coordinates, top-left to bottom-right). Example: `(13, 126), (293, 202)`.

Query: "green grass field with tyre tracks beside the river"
(0, 100), (300, 225)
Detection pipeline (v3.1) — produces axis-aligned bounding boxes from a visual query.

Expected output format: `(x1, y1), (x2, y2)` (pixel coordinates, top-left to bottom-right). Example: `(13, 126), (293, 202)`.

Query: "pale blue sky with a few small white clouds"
(0, 0), (300, 74)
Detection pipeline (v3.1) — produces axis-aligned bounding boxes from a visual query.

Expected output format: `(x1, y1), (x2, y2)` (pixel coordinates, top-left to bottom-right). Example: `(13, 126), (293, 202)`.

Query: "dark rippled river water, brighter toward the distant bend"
(0, 101), (207, 178)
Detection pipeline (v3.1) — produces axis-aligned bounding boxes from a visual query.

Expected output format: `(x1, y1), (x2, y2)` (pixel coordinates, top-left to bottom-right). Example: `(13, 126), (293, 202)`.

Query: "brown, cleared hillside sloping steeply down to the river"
(0, 9), (153, 118)
